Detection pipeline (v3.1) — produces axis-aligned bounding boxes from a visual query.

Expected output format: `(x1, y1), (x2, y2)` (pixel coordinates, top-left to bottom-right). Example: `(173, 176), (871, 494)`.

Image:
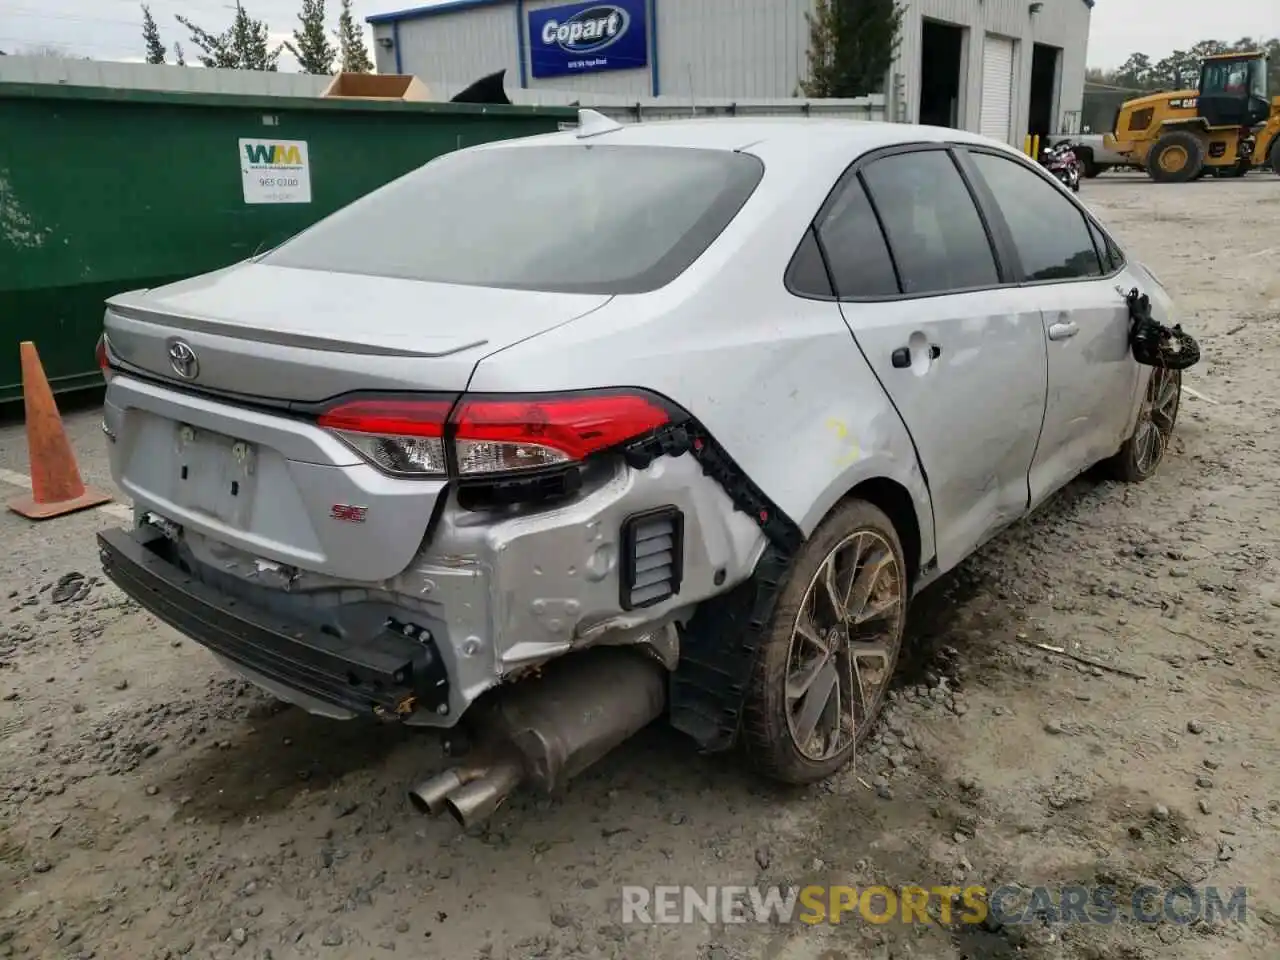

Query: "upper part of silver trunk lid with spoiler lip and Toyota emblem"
(106, 261), (609, 403)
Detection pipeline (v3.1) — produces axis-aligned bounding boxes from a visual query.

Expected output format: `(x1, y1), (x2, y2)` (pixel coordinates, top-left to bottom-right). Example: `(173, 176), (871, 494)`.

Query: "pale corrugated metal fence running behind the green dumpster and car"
(0, 56), (886, 123)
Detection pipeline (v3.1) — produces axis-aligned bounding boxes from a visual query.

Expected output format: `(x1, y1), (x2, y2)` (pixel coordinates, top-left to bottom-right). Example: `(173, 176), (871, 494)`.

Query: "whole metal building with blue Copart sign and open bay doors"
(369, 0), (1093, 143)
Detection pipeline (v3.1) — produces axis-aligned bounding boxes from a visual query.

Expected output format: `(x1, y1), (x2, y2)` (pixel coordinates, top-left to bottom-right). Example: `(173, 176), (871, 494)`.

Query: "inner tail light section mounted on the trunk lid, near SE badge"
(317, 399), (453, 479)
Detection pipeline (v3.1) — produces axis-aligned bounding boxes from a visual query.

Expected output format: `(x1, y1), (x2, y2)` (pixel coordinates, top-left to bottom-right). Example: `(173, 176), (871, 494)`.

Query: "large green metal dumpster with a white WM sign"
(0, 83), (575, 403)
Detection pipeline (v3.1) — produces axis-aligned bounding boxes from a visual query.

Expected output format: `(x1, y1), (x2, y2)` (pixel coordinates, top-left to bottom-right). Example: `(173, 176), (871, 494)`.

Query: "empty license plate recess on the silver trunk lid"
(173, 424), (257, 529)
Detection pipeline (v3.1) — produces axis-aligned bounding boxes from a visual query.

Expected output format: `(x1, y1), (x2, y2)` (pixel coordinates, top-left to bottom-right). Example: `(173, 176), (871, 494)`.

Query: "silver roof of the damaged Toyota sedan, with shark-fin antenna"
(476, 116), (1012, 167)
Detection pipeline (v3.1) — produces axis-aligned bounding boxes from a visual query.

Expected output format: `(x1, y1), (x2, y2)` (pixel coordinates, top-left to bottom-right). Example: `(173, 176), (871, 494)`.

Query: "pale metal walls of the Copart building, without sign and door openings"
(374, 0), (1091, 143)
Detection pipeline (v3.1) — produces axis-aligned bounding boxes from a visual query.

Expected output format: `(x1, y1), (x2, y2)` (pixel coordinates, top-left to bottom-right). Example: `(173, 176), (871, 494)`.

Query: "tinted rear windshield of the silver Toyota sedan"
(260, 145), (764, 293)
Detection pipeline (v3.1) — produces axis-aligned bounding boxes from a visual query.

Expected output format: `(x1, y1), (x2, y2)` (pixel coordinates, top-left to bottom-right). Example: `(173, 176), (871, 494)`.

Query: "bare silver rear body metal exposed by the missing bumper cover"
(104, 442), (765, 727)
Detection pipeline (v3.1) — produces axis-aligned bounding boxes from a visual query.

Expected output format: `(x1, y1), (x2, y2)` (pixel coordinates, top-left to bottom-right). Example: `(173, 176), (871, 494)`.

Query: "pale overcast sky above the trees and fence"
(0, 0), (1280, 69)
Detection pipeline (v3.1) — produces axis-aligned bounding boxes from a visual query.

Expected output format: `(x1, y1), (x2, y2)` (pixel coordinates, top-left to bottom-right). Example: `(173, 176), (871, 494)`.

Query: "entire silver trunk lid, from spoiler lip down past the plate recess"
(104, 262), (609, 589)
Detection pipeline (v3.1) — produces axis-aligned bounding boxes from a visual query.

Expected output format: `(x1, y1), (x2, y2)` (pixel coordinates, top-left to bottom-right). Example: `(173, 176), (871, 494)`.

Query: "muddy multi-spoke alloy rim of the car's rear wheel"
(786, 530), (908, 762)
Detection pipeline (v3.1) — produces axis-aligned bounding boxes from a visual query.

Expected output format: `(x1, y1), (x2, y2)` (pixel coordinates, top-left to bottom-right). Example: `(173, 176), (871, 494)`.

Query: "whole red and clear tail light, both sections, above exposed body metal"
(317, 390), (673, 479)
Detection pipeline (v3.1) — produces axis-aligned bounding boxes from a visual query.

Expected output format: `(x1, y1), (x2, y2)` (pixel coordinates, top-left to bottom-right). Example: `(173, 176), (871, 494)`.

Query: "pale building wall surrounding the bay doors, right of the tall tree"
(891, 0), (1092, 143)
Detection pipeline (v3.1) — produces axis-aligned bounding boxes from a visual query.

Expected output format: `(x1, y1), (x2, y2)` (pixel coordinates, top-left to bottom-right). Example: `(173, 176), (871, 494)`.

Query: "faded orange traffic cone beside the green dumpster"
(9, 340), (111, 520)
